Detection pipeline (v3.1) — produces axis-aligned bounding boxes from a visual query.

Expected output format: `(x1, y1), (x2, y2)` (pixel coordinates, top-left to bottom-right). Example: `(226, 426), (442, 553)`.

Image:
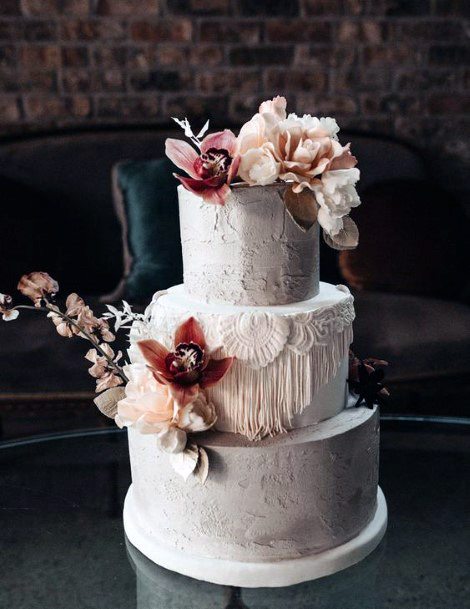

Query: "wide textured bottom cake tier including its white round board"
(124, 408), (387, 587)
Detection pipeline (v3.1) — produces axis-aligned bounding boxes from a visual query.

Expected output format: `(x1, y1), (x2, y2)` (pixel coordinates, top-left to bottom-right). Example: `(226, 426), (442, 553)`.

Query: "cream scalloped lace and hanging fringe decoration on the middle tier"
(138, 286), (355, 440)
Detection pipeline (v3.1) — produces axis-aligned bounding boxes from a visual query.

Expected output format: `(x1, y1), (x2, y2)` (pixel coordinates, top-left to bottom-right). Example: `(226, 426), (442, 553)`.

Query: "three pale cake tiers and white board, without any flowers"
(124, 177), (386, 586)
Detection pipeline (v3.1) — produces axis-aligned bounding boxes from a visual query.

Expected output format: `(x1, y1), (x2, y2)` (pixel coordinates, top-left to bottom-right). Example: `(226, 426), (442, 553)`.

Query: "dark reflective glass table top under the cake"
(0, 417), (470, 609)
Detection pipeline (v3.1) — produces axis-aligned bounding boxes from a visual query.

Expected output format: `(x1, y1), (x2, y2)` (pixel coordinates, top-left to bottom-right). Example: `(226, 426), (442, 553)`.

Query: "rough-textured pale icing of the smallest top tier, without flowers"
(178, 184), (319, 305)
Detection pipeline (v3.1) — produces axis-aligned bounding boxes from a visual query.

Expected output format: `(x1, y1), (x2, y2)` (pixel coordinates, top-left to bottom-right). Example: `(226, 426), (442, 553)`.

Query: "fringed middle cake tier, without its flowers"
(131, 283), (354, 439)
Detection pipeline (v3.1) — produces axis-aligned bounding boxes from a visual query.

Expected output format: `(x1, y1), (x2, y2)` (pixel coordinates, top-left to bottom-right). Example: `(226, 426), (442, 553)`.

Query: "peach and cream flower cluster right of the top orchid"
(238, 97), (360, 249)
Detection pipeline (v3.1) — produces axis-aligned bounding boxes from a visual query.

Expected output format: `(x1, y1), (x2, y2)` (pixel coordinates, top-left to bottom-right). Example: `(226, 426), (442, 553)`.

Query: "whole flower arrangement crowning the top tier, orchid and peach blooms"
(166, 96), (360, 249)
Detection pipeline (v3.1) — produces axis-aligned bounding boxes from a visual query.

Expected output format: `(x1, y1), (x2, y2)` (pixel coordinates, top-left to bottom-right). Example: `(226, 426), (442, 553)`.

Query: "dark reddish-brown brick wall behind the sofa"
(0, 0), (470, 192)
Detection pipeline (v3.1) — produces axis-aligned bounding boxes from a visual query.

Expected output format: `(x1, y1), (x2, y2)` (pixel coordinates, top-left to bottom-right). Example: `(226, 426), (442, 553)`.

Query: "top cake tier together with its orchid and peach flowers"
(166, 97), (360, 305)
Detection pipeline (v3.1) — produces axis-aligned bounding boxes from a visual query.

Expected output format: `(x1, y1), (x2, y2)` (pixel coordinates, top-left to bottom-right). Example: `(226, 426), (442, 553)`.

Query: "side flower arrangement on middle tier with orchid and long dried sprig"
(0, 272), (234, 484)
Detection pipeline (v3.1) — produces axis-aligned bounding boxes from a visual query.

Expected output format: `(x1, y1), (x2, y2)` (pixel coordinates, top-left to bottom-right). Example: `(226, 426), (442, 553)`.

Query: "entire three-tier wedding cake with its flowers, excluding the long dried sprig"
(120, 97), (387, 587)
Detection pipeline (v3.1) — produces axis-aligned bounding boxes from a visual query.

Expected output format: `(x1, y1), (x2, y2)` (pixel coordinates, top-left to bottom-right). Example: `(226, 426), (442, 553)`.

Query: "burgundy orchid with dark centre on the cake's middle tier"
(137, 317), (235, 407)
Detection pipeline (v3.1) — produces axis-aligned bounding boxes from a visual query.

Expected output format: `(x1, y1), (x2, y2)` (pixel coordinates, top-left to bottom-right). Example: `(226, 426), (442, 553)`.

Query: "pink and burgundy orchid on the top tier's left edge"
(165, 129), (240, 205)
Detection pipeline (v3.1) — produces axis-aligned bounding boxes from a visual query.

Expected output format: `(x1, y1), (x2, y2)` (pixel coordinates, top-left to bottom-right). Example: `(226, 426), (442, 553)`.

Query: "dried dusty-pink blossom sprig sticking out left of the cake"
(0, 271), (127, 392)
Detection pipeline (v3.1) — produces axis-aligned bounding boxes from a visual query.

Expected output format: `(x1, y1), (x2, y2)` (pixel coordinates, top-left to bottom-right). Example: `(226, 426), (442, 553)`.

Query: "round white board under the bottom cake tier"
(124, 485), (387, 588)
